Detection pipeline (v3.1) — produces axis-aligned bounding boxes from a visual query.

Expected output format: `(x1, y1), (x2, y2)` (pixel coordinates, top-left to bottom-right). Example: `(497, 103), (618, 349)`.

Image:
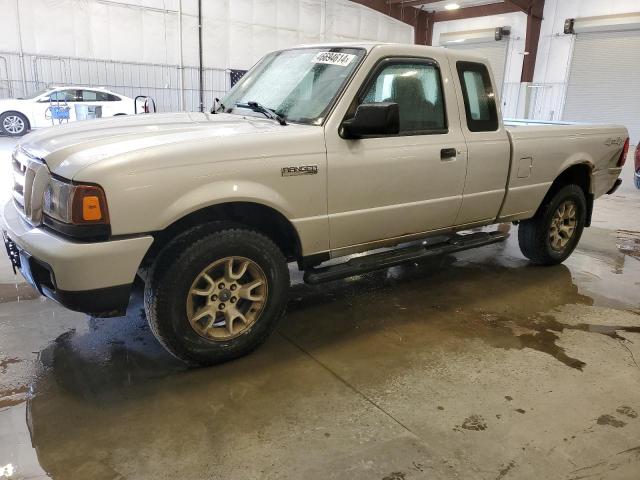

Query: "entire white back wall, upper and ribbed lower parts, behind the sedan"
(0, 0), (414, 111)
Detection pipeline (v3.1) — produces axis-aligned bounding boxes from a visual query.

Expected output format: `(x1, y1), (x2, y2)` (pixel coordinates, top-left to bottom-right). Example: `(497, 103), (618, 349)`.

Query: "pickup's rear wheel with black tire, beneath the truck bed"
(518, 185), (587, 265)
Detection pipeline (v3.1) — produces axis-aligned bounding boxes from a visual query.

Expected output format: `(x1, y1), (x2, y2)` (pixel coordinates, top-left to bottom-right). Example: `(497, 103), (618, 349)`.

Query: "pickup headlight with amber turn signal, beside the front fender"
(42, 178), (110, 238)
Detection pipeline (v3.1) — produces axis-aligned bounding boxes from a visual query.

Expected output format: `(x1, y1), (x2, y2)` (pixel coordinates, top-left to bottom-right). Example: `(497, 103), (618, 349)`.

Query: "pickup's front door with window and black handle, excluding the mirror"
(326, 58), (467, 253)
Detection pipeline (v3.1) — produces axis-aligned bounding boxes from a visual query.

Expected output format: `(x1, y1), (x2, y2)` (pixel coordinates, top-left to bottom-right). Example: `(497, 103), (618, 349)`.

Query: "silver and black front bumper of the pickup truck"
(1, 200), (153, 316)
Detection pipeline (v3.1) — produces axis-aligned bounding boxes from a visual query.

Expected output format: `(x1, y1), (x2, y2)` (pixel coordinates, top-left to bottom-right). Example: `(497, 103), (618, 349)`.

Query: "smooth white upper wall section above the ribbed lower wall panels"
(0, 0), (413, 68)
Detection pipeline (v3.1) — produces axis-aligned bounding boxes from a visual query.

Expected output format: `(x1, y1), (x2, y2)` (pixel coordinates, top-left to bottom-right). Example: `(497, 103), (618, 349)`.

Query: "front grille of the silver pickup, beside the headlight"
(11, 147), (49, 225)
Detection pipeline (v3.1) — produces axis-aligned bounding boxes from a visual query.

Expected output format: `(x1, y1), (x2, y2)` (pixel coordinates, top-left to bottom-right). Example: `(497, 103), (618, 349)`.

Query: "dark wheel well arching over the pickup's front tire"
(143, 202), (302, 264)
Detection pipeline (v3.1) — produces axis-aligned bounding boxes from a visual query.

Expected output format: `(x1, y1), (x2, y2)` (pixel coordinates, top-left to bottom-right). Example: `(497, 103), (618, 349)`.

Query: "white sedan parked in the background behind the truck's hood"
(0, 86), (135, 137)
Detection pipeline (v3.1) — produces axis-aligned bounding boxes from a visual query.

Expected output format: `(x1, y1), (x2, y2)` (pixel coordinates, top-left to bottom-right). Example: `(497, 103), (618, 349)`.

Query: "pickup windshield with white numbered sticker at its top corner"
(221, 48), (366, 125)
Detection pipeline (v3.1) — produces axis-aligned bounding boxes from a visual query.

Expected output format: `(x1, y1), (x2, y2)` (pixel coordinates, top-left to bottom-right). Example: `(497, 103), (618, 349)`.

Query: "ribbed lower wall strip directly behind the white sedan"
(0, 52), (231, 112)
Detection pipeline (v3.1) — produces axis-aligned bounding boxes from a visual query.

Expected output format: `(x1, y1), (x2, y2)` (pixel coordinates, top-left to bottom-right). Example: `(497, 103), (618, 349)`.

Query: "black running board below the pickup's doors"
(304, 232), (509, 284)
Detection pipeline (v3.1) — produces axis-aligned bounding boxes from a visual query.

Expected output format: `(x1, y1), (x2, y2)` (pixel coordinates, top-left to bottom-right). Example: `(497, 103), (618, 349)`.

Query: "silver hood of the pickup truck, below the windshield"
(21, 113), (310, 178)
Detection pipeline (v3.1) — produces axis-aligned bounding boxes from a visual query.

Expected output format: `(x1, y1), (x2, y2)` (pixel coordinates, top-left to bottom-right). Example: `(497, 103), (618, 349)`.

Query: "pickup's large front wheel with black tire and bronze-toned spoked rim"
(144, 223), (289, 365)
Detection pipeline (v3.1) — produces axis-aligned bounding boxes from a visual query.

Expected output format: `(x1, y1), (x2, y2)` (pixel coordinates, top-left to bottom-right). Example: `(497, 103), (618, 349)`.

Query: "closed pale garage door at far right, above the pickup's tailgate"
(563, 30), (640, 144)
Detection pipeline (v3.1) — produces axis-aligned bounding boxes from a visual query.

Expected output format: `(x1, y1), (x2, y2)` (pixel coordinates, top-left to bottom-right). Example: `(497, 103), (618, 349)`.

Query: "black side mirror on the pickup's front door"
(342, 102), (400, 138)
